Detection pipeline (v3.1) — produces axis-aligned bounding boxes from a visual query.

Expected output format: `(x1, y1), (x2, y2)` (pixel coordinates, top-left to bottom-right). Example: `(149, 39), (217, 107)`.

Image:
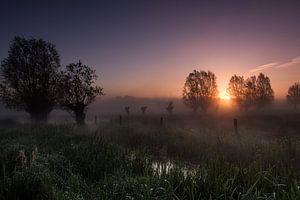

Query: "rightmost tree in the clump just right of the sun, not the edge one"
(255, 73), (274, 109)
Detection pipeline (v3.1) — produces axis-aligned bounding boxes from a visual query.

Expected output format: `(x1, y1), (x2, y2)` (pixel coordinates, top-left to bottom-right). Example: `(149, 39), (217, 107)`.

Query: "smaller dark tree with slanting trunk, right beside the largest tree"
(60, 61), (103, 126)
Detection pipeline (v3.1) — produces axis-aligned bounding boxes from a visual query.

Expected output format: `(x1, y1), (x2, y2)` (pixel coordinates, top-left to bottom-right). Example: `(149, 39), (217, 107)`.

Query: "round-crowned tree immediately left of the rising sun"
(183, 70), (218, 112)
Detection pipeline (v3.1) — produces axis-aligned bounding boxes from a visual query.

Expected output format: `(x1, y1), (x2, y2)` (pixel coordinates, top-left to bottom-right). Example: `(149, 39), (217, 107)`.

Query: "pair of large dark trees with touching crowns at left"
(0, 37), (103, 126)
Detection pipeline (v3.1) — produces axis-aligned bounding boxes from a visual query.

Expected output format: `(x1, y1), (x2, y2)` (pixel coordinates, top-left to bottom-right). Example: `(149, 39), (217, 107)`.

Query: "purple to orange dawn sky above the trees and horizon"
(0, 0), (300, 98)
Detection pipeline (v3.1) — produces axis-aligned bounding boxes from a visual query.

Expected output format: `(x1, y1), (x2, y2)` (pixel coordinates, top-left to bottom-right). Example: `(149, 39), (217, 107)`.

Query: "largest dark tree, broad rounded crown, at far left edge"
(0, 37), (60, 122)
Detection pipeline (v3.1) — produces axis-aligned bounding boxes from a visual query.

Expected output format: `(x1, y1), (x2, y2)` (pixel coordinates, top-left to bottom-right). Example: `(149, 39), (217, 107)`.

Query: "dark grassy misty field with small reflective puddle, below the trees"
(0, 114), (300, 200)
